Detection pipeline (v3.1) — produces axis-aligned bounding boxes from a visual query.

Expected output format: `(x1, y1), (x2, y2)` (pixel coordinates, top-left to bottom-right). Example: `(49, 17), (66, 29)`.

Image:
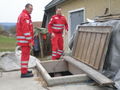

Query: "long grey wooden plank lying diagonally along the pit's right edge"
(63, 56), (114, 85)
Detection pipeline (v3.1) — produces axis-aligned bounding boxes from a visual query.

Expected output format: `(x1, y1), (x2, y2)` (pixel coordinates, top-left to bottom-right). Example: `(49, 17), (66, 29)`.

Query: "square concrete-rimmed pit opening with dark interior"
(37, 60), (89, 86)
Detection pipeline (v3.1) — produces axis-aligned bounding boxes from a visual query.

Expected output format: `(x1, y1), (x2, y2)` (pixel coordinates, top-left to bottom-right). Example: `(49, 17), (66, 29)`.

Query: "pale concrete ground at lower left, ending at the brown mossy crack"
(0, 71), (46, 90)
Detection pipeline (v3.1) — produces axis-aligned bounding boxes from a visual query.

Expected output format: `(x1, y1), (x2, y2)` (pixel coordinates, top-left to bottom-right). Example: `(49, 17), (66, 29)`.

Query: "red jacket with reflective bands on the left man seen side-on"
(16, 10), (33, 46)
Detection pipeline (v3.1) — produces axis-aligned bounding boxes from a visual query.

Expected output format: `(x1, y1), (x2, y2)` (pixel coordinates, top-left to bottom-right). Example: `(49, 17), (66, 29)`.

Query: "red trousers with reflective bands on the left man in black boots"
(21, 46), (30, 74)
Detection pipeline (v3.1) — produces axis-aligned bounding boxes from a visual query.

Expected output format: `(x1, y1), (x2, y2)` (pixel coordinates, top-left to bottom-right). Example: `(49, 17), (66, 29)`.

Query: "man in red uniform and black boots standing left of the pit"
(16, 4), (34, 78)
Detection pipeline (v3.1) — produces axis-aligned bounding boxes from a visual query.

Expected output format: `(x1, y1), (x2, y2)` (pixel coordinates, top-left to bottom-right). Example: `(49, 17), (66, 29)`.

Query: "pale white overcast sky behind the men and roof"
(0, 0), (52, 23)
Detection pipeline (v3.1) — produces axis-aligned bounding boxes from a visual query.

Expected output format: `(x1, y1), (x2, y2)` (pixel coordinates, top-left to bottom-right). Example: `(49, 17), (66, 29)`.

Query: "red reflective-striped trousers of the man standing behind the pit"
(51, 34), (63, 60)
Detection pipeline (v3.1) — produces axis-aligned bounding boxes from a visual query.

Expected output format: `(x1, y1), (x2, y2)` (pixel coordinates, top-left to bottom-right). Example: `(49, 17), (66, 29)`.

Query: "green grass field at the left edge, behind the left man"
(0, 35), (16, 52)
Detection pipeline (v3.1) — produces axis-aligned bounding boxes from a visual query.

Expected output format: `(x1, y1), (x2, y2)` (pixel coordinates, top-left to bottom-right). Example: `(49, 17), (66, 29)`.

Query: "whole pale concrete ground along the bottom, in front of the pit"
(0, 71), (113, 90)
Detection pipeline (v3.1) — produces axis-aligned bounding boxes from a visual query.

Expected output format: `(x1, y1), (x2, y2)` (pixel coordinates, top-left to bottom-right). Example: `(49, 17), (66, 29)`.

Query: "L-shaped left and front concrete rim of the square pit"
(36, 61), (89, 86)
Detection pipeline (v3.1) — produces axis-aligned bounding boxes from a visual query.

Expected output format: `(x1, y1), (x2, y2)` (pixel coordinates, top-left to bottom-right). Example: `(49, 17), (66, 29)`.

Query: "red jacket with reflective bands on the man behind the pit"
(48, 14), (68, 34)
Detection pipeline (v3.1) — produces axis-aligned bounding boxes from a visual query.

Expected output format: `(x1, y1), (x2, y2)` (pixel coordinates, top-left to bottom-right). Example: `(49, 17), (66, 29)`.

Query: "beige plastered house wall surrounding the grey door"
(57, 0), (120, 52)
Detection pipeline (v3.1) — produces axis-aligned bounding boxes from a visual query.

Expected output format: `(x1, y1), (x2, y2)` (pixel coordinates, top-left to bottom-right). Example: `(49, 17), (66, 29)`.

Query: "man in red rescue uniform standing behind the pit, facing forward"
(48, 8), (68, 60)
